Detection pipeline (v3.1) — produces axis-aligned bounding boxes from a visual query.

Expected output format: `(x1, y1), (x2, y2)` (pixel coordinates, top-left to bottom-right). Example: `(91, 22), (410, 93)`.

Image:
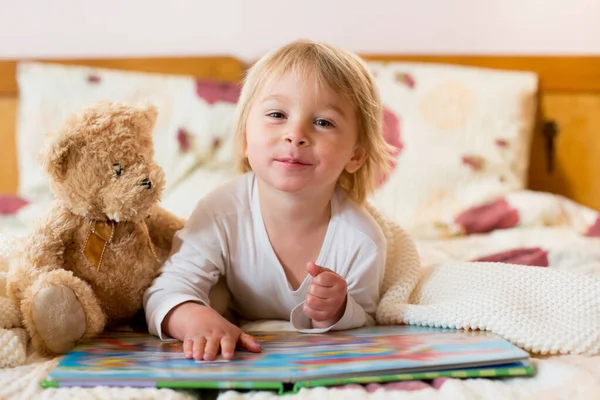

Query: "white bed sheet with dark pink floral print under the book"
(0, 193), (600, 400)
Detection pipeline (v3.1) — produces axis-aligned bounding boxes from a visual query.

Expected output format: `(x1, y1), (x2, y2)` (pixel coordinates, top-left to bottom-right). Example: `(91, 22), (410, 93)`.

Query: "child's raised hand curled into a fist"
(303, 261), (347, 328)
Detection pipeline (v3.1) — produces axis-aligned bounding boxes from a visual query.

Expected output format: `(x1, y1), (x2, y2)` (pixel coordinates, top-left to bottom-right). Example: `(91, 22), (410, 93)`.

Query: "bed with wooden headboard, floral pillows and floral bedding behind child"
(0, 55), (600, 399)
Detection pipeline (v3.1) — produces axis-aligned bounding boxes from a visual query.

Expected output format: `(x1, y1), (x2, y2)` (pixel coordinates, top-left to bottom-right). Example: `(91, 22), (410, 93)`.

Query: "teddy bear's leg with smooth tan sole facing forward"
(21, 269), (106, 355)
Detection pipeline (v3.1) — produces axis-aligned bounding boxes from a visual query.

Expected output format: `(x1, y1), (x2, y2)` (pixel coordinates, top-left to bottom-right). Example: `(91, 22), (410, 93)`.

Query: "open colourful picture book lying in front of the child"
(42, 325), (533, 393)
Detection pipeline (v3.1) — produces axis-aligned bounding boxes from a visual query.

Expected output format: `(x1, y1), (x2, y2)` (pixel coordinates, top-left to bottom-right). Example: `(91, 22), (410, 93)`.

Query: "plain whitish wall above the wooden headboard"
(0, 0), (600, 59)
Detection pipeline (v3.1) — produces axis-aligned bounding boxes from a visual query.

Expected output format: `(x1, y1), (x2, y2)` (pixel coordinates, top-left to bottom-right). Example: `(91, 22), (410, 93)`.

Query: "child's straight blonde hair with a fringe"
(234, 40), (392, 203)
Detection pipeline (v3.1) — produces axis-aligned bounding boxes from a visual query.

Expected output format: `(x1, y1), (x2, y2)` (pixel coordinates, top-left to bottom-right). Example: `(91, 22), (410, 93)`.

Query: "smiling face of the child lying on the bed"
(246, 74), (365, 197)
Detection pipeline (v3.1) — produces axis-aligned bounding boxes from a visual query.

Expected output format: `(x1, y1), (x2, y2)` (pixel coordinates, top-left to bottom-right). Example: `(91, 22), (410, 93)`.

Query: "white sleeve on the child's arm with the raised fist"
(290, 245), (386, 333)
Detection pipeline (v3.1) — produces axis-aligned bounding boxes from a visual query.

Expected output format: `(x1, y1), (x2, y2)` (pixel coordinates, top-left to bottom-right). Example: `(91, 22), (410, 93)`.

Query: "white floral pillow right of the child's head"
(367, 61), (538, 237)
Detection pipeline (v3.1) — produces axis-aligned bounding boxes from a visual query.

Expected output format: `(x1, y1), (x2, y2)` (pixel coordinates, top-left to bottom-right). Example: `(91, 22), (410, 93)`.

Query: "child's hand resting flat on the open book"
(165, 303), (261, 361)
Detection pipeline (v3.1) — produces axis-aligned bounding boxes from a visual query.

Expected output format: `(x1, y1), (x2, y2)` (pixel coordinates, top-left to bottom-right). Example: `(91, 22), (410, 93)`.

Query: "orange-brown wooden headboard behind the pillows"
(0, 55), (600, 210)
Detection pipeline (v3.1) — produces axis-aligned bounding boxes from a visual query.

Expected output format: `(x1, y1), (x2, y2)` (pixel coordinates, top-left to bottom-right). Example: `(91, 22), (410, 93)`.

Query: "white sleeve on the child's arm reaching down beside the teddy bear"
(143, 206), (226, 340)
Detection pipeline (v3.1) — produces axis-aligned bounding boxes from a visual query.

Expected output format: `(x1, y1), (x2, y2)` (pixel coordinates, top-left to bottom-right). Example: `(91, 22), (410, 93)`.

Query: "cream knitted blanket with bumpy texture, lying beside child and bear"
(0, 206), (600, 376)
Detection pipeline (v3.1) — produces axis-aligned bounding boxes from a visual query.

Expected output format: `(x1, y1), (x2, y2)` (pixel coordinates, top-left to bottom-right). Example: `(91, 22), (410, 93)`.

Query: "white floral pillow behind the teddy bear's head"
(16, 62), (239, 208)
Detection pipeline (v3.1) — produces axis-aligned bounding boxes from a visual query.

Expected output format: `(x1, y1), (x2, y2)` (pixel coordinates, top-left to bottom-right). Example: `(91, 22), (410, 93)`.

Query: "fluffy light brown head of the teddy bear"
(40, 101), (165, 222)
